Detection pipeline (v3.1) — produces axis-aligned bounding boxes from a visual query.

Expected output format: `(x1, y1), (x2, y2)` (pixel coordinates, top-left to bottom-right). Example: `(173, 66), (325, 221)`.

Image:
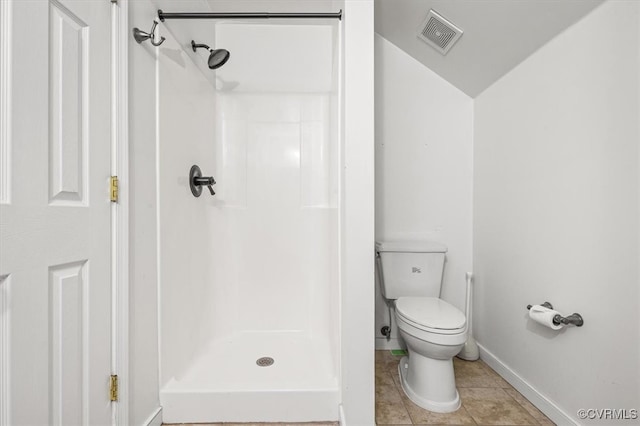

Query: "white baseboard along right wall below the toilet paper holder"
(478, 343), (580, 426)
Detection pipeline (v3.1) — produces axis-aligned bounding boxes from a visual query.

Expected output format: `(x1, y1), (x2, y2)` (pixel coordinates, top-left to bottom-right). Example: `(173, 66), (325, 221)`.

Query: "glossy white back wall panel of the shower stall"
(212, 21), (339, 346)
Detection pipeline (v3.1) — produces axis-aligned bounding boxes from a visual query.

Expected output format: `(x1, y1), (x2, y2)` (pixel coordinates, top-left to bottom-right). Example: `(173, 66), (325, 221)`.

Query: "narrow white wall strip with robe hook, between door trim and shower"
(128, 1), (160, 425)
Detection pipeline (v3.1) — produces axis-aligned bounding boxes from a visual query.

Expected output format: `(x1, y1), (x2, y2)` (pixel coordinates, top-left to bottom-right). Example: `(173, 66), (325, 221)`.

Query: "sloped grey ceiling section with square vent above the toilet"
(375, 0), (604, 97)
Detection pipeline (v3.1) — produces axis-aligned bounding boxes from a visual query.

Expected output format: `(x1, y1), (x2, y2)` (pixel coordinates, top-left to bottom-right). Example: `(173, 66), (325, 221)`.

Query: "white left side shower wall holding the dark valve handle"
(157, 23), (215, 386)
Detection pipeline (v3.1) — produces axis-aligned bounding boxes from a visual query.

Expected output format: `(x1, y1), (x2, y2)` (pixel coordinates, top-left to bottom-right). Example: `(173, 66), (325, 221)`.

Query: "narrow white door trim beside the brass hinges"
(110, 0), (129, 425)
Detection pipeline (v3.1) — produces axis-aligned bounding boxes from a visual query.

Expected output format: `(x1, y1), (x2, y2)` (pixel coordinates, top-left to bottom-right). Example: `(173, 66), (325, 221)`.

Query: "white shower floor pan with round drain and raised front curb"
(160, 332), (339, 423)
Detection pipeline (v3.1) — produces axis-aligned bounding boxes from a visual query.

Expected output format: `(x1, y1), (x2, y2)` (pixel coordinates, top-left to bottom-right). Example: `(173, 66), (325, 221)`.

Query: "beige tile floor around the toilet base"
(376, 351), (554, 426)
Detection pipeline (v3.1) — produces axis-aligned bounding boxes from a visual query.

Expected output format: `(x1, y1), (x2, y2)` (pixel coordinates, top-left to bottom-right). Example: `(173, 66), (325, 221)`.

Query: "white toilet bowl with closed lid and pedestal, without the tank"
(395, 297), (467, 413)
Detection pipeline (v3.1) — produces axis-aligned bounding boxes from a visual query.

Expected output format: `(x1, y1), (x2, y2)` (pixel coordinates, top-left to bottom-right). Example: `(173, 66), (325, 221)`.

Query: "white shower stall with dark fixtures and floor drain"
(148, 2), (358, 423)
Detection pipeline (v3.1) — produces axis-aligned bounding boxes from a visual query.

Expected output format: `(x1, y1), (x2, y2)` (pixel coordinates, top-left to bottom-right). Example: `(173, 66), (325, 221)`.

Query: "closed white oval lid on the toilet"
(396, 297), (466, 330)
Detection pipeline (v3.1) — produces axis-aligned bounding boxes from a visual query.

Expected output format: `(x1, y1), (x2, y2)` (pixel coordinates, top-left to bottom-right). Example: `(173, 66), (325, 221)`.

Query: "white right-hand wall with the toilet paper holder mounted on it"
(474, 1), (640, 424)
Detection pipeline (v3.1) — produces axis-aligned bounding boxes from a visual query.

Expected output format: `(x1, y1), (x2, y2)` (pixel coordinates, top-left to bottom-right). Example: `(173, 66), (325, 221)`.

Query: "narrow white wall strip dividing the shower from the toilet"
(340, 0), (375, 425)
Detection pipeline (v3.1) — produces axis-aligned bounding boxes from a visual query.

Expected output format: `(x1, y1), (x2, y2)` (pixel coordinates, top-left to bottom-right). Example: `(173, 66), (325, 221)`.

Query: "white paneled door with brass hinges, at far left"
(0, 0), (111, 426)
